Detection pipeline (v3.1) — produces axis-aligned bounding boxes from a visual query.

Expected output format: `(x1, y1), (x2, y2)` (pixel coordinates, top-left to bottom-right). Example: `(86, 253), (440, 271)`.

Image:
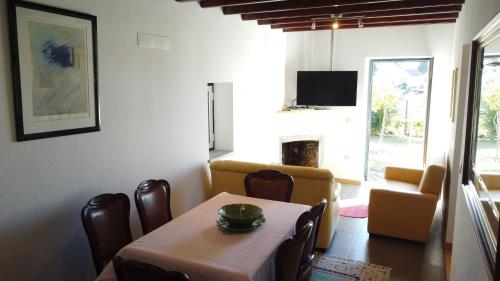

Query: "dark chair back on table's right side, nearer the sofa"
(295, 198), (327, 266)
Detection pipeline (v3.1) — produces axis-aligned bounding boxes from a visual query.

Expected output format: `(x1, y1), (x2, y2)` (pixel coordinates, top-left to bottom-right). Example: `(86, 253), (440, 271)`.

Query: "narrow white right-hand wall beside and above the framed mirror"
(446, 0), (500, 243)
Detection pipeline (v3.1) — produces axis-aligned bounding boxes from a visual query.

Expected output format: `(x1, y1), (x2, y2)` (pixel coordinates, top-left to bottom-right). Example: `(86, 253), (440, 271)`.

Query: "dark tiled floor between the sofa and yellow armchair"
(327, 184), (446, 281)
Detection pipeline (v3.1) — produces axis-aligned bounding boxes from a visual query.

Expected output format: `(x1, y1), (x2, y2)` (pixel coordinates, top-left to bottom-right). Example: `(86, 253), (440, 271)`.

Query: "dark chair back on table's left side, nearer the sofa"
(134, 180), (172, 234)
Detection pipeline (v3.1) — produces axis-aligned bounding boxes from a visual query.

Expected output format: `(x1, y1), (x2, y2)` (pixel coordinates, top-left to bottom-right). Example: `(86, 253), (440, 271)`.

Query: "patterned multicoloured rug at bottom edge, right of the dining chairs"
(312, 254), (391, 281)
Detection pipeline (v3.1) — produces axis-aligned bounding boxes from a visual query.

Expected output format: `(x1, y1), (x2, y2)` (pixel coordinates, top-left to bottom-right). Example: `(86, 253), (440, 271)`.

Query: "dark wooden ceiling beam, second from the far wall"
(271, 13), (458, 29)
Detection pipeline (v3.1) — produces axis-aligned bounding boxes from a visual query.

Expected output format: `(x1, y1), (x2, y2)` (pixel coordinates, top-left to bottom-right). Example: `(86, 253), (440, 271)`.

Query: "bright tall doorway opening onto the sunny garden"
(364, 58), (432, 181)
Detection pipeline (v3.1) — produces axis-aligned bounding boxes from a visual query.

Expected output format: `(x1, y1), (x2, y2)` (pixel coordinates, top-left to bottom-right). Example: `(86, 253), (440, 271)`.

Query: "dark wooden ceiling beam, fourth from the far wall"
(241, 0), (464, 20)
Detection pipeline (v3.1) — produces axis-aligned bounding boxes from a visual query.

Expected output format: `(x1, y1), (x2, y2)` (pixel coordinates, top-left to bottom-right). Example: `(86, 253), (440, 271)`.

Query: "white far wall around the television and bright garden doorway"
(282, 24), (453, 180)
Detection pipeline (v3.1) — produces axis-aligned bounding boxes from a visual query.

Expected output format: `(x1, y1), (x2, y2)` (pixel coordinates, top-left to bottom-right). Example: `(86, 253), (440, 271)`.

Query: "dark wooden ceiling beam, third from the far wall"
(257, 5), (462, 25)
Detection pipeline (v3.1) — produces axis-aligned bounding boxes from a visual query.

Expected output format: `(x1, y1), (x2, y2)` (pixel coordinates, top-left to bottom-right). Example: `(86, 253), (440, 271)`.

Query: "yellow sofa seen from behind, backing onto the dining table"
(210, 160), (340, 249)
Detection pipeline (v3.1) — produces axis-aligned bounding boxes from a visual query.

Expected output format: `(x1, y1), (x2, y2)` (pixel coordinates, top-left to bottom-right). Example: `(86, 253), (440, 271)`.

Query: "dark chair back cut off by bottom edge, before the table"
(113, 256), (189, 281)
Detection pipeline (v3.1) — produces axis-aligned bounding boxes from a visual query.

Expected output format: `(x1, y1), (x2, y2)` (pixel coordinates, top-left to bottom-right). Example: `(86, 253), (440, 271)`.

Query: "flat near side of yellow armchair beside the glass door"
(368, 186), (438, 241)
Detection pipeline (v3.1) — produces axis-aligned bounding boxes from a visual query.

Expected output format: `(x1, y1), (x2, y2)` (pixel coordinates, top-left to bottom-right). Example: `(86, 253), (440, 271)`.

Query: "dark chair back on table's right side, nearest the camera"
(274, 221), (313, 281)
